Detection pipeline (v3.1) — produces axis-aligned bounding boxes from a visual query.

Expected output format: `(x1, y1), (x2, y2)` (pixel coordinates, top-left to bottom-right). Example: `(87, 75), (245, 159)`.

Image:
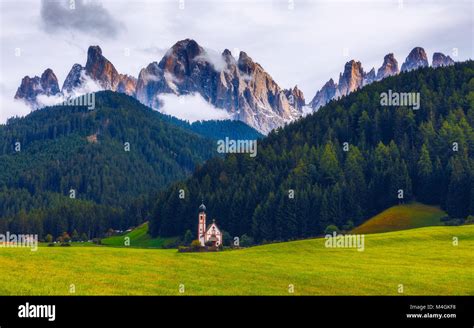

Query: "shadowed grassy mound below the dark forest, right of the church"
(352, 203), (446, 234)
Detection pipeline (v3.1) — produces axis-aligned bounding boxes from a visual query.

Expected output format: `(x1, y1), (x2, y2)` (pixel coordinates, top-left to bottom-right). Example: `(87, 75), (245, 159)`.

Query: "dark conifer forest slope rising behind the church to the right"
(150, 61), (474, 242)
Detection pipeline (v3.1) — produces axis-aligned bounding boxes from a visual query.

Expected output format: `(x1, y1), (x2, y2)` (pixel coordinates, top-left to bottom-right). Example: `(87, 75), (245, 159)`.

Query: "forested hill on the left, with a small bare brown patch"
(0, 91), (217, 236)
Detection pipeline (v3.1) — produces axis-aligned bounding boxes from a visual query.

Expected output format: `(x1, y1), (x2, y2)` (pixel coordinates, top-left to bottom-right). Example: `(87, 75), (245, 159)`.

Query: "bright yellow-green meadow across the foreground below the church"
(0, 225), (474, 295)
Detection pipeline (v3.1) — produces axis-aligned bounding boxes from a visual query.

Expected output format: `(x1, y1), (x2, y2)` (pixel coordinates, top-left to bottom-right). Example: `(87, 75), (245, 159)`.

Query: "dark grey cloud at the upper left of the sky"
(41, 0), (123, 37)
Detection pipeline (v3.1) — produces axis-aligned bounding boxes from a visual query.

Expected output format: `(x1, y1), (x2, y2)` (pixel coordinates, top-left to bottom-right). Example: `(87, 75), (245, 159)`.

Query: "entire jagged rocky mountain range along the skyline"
(15, 39), (454, 134)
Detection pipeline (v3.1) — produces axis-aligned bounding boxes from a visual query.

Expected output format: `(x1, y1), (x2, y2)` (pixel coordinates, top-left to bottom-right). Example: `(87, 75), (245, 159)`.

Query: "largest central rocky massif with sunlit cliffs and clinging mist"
(136, 39), (304, 133)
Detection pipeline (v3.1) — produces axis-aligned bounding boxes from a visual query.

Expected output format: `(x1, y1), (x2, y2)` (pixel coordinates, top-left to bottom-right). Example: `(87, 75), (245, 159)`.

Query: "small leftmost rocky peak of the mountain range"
(15, 68), (59, 108)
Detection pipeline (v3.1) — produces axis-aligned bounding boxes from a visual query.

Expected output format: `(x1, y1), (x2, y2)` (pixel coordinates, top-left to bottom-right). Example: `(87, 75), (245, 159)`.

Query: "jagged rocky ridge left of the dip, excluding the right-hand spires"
(15, 39), (305, 133)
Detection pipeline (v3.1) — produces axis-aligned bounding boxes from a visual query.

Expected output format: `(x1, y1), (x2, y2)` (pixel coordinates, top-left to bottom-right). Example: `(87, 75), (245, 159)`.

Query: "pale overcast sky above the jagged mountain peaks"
(0, 0), (474, 123)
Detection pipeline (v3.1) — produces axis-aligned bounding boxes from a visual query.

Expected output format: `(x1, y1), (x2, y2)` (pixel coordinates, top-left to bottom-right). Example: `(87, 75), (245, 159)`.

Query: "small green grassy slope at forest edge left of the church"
(101, 222), (173, 248)
